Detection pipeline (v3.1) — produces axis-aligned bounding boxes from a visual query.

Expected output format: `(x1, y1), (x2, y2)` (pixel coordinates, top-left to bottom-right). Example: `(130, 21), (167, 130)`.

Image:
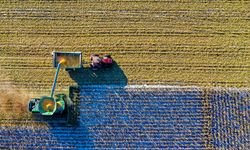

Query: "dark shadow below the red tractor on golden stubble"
(68, 61), (128, 86)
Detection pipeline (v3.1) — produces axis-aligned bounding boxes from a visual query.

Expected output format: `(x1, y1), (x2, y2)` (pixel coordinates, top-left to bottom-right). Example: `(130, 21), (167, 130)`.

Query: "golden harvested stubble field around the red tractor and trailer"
(0, 0), (250, 93)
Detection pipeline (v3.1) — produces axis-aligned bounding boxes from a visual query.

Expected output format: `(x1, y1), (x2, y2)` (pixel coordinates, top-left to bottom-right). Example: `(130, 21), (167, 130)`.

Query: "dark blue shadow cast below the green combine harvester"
(31, 114), (94, 149)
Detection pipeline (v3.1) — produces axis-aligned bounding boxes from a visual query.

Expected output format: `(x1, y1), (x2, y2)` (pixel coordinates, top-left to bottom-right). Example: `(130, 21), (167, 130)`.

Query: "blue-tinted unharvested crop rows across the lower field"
(0, 85), (250, 150)
